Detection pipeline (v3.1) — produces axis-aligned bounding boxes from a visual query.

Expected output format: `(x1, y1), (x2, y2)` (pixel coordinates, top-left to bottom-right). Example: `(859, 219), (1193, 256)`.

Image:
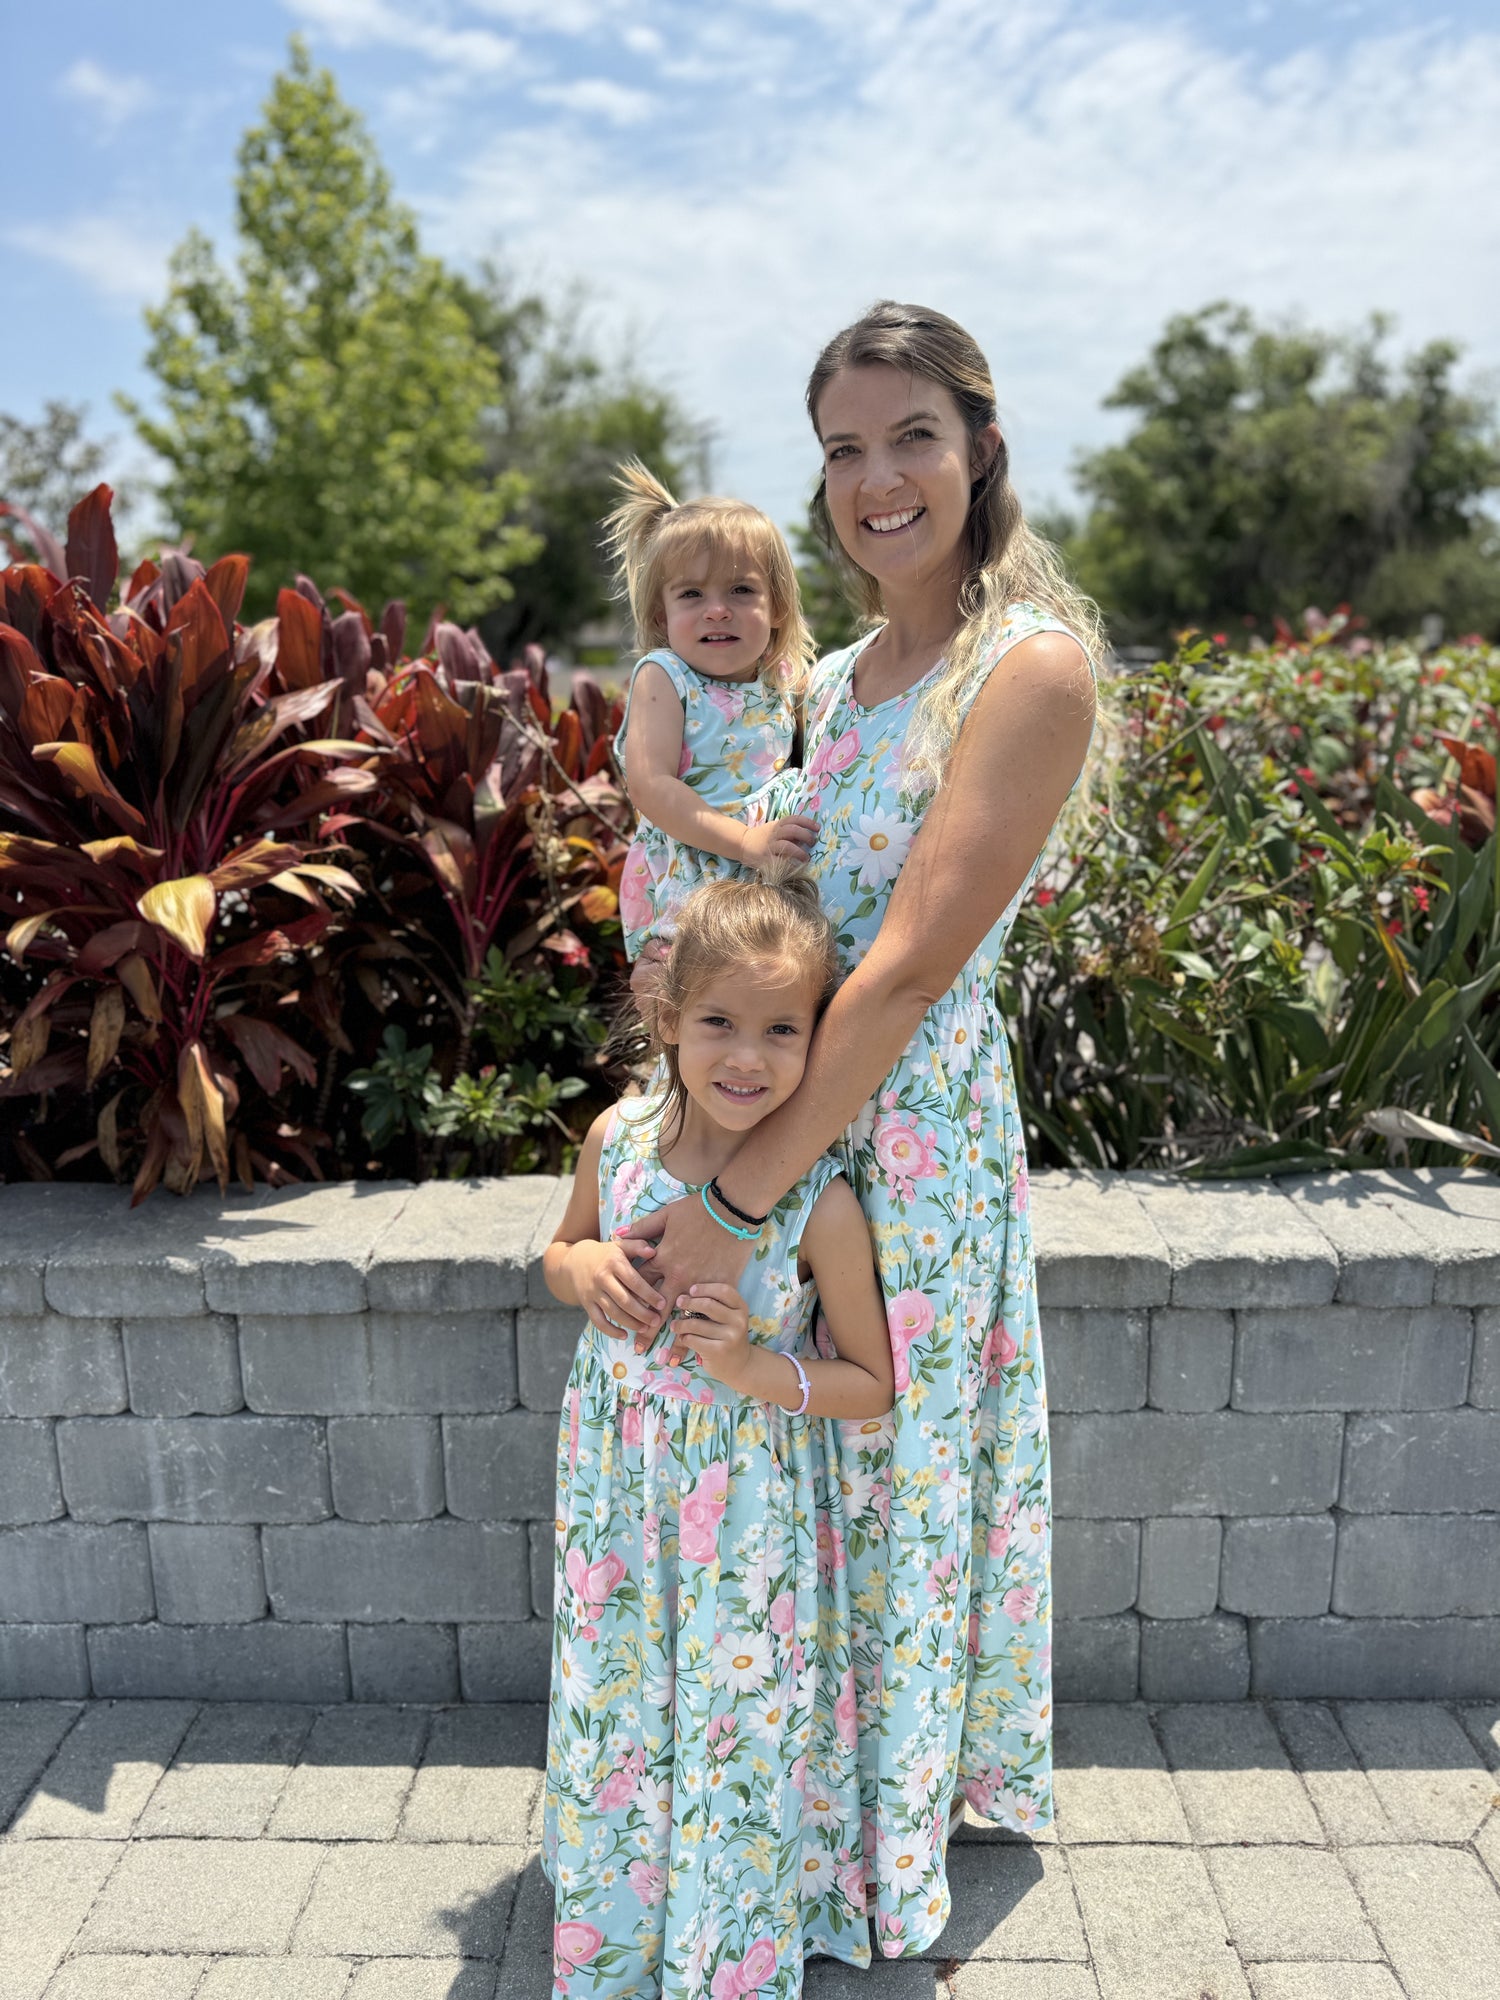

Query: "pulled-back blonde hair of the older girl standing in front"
(642, 860), (838, 1160)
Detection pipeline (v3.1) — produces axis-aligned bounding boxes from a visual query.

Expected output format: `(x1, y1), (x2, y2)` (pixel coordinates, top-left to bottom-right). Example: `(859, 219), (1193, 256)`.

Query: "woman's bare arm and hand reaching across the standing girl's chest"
(636, 632), (1094, 1298)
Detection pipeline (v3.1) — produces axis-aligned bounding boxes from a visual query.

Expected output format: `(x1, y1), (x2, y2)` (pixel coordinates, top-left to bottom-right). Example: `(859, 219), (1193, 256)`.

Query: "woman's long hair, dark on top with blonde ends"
(808, 298), (1106, 790)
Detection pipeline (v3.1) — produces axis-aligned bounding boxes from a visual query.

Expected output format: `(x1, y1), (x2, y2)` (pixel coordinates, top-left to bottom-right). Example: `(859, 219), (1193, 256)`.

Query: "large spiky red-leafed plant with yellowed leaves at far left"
(0, 486), (378, 1200)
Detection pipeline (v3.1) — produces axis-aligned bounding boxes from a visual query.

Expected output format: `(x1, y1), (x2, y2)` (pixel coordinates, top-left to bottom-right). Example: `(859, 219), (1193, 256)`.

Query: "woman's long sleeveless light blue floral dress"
(768, 604), (1066, 1958)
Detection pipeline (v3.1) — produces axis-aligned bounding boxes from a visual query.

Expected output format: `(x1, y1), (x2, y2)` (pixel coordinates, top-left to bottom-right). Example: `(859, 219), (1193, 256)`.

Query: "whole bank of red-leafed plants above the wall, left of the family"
(0, 488), (630, 1198)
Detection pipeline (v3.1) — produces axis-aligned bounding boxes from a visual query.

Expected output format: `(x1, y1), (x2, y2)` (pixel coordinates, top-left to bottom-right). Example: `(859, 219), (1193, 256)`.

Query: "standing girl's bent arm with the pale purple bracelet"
(674, 1178), (896, 1416)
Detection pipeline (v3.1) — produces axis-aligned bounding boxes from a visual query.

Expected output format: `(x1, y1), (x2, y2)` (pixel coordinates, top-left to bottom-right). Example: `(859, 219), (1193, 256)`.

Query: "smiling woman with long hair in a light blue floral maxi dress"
(636, 302), (1100, 1958)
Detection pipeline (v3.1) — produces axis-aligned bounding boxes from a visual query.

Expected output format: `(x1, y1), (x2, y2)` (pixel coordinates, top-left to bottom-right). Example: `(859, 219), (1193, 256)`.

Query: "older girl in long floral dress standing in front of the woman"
(544, 866), (894, 2000)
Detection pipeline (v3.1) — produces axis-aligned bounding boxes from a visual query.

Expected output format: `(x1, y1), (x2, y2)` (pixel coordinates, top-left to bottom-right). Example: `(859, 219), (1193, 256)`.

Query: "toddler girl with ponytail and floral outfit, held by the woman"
(604, 460), (818, 986)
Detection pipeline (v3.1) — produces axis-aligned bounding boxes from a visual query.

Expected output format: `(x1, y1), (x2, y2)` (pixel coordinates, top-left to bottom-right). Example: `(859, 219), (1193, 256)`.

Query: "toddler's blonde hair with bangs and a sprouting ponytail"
(604, 458), (816, 694)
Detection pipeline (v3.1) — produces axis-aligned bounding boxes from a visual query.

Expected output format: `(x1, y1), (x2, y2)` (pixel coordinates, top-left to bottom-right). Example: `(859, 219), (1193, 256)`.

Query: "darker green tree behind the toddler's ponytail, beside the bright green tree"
(460, 264), (702, 652)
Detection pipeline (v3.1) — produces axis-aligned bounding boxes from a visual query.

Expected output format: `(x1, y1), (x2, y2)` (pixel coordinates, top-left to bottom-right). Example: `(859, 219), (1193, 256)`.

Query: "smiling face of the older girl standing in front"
(662, 966), (818, 1132)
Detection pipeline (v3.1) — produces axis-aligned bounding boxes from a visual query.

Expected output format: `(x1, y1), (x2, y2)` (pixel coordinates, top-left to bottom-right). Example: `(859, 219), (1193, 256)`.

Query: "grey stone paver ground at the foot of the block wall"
(0, 1702), (1500, 2000)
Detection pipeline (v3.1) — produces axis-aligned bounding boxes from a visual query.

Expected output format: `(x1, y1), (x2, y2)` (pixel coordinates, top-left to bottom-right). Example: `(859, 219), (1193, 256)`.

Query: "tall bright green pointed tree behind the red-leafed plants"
(122, 38), (536, 616)
